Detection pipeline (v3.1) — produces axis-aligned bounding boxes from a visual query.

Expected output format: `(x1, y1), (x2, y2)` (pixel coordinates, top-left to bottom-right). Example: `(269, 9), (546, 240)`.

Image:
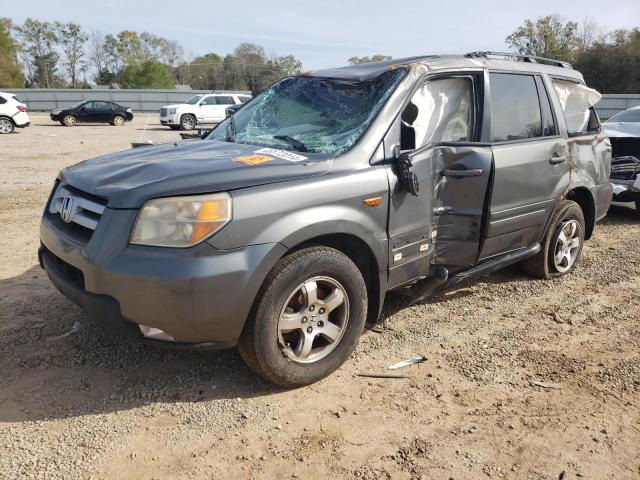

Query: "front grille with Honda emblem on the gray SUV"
(49, 184), (106, 238)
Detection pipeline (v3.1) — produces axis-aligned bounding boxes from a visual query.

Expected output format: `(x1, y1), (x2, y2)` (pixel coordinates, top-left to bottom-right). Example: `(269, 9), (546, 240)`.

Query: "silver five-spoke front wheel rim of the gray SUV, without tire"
(278, 276), (349, 364)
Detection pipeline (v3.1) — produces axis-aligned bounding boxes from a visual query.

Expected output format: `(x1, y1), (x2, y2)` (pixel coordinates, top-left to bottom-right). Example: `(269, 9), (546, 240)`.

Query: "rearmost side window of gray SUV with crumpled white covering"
(553, 79), (600, 135)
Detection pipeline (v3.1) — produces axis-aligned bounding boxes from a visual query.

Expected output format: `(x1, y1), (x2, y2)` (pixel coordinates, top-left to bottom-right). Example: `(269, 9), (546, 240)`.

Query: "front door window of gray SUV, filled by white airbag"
(400, 77), (473, 150)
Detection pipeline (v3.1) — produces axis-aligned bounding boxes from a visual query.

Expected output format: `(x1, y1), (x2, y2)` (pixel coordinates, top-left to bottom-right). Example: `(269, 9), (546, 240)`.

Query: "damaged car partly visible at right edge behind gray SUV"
(604, 106), (640, 210)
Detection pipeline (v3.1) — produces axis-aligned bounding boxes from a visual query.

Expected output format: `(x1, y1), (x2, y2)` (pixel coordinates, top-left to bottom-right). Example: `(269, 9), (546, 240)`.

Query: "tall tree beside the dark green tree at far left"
(16, 18), (61, 88)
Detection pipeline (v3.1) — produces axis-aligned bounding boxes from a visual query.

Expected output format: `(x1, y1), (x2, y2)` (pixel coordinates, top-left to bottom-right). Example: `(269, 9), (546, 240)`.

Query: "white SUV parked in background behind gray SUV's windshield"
(160, 93), (251, 130)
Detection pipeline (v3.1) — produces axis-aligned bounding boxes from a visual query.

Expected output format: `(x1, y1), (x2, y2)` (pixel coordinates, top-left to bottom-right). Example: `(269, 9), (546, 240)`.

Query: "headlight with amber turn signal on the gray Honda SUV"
(131, 193), (231, 248)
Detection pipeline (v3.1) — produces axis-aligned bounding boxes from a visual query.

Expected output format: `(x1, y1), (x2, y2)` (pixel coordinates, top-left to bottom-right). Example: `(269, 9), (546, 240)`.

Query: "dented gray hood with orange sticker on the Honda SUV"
(60, 140), (333, 208)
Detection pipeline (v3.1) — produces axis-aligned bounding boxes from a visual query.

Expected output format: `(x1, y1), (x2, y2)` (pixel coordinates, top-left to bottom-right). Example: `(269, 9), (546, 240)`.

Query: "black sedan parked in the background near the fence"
(49, 100), (133, 127)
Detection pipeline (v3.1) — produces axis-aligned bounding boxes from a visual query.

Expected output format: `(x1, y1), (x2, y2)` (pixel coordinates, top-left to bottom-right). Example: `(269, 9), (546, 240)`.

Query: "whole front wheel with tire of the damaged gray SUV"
(238, 247), (368, 388)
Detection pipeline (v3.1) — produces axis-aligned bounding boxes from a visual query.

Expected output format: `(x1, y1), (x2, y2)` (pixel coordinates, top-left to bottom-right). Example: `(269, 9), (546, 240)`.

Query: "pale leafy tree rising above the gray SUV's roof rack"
(505, 15), (580, 62)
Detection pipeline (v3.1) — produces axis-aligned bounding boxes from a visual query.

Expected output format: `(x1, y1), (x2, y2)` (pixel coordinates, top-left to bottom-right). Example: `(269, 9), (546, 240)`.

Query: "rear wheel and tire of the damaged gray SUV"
(522, 200), (585, 279)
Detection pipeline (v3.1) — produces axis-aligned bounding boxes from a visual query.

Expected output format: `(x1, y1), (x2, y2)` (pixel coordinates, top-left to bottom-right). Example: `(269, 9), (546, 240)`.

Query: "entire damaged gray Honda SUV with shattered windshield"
(39, 52), (611, 387)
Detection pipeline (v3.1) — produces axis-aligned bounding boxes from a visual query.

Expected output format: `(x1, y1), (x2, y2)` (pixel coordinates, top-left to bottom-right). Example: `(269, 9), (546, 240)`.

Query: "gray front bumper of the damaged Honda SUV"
(39, 208), (285, 348)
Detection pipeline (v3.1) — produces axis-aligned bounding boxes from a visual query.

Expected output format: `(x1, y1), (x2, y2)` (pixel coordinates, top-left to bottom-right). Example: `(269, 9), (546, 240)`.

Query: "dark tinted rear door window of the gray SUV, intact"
(491, 73), (542, 142)
